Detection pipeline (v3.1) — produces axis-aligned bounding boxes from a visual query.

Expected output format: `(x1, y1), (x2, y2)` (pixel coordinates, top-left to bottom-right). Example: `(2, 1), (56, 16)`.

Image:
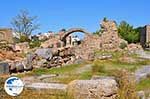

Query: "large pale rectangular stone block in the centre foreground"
(68, 79), (118, 99)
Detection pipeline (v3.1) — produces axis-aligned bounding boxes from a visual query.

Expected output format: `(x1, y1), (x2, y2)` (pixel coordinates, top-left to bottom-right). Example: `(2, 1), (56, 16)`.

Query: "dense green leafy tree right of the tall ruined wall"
(118, 21), (140, 43)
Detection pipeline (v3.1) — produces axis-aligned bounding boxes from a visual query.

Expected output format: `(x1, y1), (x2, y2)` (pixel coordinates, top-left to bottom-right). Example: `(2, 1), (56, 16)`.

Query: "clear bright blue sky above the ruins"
(0, 0), (150, 32)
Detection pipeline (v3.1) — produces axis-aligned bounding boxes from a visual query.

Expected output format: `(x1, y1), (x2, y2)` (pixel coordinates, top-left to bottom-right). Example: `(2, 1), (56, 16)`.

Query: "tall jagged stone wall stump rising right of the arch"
(100, 21), (120, 50)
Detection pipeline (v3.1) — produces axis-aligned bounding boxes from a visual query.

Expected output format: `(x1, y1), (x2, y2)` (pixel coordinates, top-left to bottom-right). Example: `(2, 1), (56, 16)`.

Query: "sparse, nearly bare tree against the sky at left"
(11, 10), (39, 38)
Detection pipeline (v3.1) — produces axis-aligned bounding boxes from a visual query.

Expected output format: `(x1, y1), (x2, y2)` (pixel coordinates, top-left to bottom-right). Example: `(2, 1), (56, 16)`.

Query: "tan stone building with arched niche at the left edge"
(0, 28), (13, 43)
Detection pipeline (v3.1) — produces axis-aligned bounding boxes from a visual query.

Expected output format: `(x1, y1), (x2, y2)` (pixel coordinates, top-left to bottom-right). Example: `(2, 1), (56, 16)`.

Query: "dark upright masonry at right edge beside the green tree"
(140, 25), (150, 48)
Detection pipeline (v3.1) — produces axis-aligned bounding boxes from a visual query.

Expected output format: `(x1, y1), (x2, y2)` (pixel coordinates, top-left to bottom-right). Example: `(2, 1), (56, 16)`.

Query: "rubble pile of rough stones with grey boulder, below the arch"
(32, 48), (75, 68)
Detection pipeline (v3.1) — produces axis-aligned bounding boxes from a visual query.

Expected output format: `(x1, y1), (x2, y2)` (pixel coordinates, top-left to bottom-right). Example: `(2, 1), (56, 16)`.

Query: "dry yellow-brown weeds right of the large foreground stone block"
(113, 70), (138, 99)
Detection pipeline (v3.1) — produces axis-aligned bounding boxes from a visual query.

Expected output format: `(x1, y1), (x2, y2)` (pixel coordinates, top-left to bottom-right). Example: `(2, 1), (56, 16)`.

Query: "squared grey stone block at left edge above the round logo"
(0, 62), (9, 74)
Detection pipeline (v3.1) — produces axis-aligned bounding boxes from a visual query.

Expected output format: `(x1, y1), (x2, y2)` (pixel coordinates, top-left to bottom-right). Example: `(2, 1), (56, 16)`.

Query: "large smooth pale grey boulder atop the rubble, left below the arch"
(35, 48), (53, 60)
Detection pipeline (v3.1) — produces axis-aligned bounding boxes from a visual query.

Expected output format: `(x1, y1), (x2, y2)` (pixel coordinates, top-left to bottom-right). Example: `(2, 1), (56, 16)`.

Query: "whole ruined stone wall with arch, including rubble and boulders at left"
(0, 20), (142, 72)
